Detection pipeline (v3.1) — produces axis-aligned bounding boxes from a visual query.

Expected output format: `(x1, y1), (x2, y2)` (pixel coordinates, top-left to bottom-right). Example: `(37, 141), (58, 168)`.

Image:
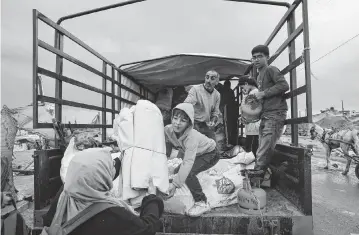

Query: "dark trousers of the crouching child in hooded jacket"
(186, 149), (219, 202)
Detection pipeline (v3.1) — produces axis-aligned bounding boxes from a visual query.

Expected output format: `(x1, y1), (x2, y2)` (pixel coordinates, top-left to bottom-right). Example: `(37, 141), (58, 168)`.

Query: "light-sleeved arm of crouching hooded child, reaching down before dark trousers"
(172, 138), (198, 188)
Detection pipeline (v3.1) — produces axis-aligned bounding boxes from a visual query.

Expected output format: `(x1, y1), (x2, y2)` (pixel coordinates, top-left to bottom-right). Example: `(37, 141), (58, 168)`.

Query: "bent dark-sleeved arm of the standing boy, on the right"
(264, 67), (289, 98)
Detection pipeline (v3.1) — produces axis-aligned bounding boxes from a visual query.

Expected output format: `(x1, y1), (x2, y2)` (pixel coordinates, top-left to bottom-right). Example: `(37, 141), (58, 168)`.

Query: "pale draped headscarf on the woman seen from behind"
(50, 148), (137, 229)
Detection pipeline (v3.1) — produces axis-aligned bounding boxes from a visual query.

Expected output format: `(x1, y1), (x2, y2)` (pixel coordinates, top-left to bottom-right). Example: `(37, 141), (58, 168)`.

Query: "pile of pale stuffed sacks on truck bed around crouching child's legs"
(164, 149), (255, 215)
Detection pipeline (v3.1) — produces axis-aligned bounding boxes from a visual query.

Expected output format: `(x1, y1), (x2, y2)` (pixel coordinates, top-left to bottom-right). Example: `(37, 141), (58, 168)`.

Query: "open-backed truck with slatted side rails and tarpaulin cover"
(25, 0), (313, 234)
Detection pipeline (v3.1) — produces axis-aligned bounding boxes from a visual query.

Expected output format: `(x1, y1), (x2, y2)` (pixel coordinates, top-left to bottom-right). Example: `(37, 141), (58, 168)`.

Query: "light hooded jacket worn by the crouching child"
(165, 103), (216, 188)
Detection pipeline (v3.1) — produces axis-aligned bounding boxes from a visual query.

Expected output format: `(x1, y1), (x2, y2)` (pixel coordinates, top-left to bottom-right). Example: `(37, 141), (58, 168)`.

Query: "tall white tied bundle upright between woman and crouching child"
(112, 100), (169, 207)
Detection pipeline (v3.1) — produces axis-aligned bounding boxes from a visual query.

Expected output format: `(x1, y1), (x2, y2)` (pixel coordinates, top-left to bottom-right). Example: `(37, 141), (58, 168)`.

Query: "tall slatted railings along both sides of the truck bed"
(33, 0), (312, 145)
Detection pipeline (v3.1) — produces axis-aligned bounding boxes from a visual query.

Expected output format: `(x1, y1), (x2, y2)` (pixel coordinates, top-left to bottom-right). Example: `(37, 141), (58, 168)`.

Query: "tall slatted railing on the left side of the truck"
(33, 9), (154, 141)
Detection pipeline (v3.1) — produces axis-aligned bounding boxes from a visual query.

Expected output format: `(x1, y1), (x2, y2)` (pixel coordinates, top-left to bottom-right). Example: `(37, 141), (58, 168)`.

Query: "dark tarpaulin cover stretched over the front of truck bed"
(121, 54), (249, 92)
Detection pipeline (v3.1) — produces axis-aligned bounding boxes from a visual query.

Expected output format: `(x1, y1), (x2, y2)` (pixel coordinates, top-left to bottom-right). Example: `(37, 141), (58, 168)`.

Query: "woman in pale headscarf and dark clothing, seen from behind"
(43, 148), (163, 235)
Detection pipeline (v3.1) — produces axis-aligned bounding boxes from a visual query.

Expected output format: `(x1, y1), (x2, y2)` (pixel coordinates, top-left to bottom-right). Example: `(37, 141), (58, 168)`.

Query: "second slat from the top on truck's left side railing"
(38, 40), (145, 99)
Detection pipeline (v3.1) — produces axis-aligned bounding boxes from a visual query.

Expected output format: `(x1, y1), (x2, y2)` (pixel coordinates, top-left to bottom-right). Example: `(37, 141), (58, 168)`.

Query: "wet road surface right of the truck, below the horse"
(312, 155), (359, 235)
